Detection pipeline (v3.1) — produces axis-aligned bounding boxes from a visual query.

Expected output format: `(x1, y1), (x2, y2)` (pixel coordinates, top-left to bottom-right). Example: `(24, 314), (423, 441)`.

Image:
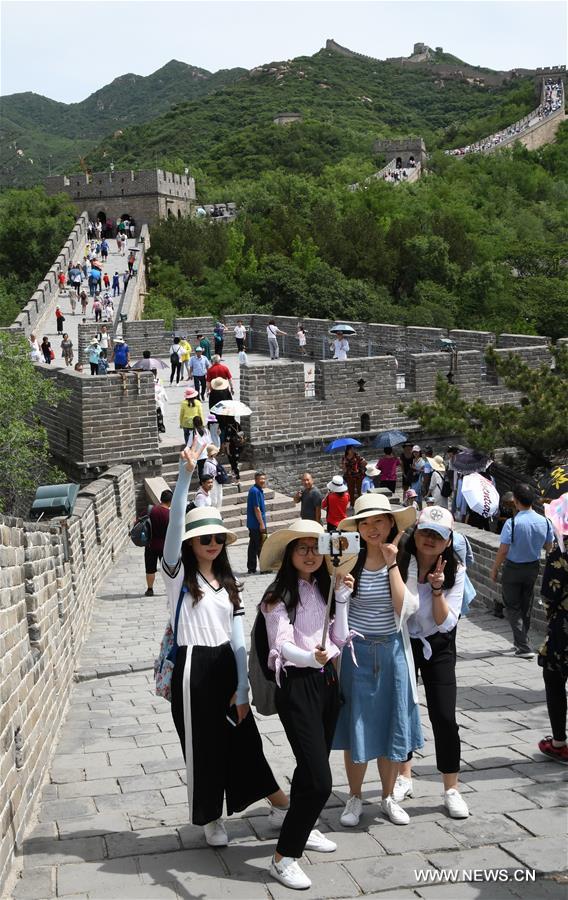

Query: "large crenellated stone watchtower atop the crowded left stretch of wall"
(45, 169), (196, 232)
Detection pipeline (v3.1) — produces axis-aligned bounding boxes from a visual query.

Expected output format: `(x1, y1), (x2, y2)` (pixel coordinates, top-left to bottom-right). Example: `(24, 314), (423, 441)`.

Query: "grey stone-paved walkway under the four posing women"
(10, 546), (568, 900)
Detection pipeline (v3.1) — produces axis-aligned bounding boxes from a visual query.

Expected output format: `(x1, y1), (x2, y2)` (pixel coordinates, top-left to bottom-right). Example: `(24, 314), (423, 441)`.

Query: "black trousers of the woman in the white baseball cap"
(410, 628), (461, 775)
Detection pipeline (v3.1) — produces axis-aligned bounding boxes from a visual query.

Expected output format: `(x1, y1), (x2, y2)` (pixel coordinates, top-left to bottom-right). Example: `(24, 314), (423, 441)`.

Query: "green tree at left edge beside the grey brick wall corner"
(0, 332), (64, 516)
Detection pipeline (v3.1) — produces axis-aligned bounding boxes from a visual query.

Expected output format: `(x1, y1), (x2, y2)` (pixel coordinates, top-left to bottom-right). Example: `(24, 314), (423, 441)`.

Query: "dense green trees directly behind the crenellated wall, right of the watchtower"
(145, 124), (568, 338)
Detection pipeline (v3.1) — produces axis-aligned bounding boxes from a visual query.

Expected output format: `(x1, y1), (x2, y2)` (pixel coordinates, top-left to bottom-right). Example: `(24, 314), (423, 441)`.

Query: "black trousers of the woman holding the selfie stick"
(275, 663), (339, 859)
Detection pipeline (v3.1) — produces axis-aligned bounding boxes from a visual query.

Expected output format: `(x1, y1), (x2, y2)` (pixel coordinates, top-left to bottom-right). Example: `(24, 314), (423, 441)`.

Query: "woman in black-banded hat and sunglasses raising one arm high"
(162, 438), (286, 847)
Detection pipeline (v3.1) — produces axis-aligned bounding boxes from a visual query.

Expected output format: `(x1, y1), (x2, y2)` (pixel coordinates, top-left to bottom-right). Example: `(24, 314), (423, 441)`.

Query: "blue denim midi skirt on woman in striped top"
(333, 632), (424, 763)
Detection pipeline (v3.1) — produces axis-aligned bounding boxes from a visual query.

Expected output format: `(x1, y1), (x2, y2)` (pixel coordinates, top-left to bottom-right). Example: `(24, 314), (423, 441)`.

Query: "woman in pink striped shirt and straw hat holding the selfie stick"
(260, 519), (352, 890)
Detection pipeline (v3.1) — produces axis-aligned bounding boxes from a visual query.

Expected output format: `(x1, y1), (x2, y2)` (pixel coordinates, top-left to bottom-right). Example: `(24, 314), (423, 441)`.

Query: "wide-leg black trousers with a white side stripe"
(172, 643), (278, 825)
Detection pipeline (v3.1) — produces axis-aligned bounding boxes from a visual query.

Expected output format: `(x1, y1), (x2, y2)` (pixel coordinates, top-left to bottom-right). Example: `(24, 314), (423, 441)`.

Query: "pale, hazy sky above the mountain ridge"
(0, 0), (567, 103)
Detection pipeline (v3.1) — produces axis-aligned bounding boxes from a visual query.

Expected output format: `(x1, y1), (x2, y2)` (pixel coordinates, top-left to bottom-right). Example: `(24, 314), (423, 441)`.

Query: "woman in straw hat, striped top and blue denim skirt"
(333, 493), (424, 827)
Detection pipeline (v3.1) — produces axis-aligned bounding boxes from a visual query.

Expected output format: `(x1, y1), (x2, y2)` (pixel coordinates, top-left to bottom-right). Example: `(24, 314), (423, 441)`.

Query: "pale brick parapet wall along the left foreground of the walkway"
(0, 466), (135, 885)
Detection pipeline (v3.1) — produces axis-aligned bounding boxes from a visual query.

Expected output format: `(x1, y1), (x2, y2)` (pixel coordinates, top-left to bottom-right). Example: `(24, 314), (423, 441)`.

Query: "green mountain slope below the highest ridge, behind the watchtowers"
(88, 50), (536, 199)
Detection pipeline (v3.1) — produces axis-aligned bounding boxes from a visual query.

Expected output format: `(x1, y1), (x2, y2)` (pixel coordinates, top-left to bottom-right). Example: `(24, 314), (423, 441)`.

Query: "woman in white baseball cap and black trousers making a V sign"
(395, 506), (469, 819)
